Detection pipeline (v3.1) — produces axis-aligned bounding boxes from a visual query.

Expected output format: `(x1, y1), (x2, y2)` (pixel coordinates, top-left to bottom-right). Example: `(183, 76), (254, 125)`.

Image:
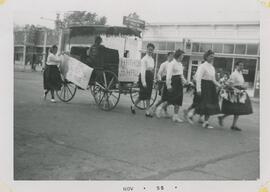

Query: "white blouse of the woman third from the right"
(166, 59), (186, 89)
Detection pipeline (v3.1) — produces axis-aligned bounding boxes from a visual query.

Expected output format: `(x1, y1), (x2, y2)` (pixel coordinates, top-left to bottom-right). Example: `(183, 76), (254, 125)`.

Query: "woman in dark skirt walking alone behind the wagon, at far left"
(43, 45), (62, 103)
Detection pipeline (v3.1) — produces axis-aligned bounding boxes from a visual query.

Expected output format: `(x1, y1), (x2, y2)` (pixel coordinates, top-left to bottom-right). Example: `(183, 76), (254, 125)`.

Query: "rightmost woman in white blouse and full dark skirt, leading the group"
(218, 61), (253, 131)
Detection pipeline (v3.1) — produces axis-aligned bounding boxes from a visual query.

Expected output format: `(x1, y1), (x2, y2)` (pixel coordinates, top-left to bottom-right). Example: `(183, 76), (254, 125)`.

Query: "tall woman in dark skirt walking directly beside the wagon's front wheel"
(130, 43), (155, 117)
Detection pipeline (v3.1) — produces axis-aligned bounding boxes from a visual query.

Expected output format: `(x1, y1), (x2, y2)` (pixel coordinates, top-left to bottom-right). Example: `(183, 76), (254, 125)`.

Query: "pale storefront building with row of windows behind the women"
(142, 22), (260, 97)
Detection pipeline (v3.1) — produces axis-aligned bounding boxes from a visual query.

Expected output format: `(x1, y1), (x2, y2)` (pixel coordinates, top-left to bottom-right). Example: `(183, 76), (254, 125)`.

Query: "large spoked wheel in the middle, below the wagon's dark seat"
(91, 71), (120, 111)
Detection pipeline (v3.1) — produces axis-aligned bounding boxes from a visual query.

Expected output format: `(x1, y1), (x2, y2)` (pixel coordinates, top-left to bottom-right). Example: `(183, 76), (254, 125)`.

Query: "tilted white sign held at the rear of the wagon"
(60, 55), (93, 89)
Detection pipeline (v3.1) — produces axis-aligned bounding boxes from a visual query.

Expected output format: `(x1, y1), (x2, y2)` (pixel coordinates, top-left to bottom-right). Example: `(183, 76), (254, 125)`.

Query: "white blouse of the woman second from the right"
(196, 61), (216, 92)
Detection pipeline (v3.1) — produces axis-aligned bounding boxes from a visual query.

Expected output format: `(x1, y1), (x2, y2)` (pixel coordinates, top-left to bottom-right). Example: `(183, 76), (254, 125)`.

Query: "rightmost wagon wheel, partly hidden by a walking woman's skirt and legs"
(130, 84), (158, 110)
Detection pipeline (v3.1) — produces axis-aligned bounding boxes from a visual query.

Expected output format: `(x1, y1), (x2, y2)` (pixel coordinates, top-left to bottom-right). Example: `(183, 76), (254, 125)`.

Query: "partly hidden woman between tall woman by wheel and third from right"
(151, 52), (174, 118)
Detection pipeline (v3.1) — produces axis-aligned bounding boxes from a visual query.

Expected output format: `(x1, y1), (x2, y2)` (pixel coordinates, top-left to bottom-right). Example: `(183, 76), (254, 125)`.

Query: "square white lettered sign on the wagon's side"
(118, 58), (141, 82)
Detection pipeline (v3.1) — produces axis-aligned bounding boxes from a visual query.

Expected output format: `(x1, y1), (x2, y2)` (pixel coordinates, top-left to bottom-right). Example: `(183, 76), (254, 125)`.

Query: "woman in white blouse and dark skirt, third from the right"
(166, 49), (186, 123)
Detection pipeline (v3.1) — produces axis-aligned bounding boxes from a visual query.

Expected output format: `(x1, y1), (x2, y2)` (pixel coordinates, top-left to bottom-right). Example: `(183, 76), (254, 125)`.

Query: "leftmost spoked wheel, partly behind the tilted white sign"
(56, 80), (77, 102)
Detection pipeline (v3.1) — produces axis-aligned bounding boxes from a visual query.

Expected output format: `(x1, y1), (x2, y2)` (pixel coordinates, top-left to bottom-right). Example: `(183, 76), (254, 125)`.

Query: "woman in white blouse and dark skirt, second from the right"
(196, 50), (220, 129)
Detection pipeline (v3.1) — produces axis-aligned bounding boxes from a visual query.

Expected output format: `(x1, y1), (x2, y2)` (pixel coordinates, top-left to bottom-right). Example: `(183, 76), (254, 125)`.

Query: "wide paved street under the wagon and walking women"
(14, 70), (259, 180)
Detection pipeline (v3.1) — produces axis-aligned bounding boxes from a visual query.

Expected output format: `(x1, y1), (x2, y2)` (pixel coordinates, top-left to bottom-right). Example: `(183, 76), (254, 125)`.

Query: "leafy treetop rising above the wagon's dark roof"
(64, 11), (107, 25)
